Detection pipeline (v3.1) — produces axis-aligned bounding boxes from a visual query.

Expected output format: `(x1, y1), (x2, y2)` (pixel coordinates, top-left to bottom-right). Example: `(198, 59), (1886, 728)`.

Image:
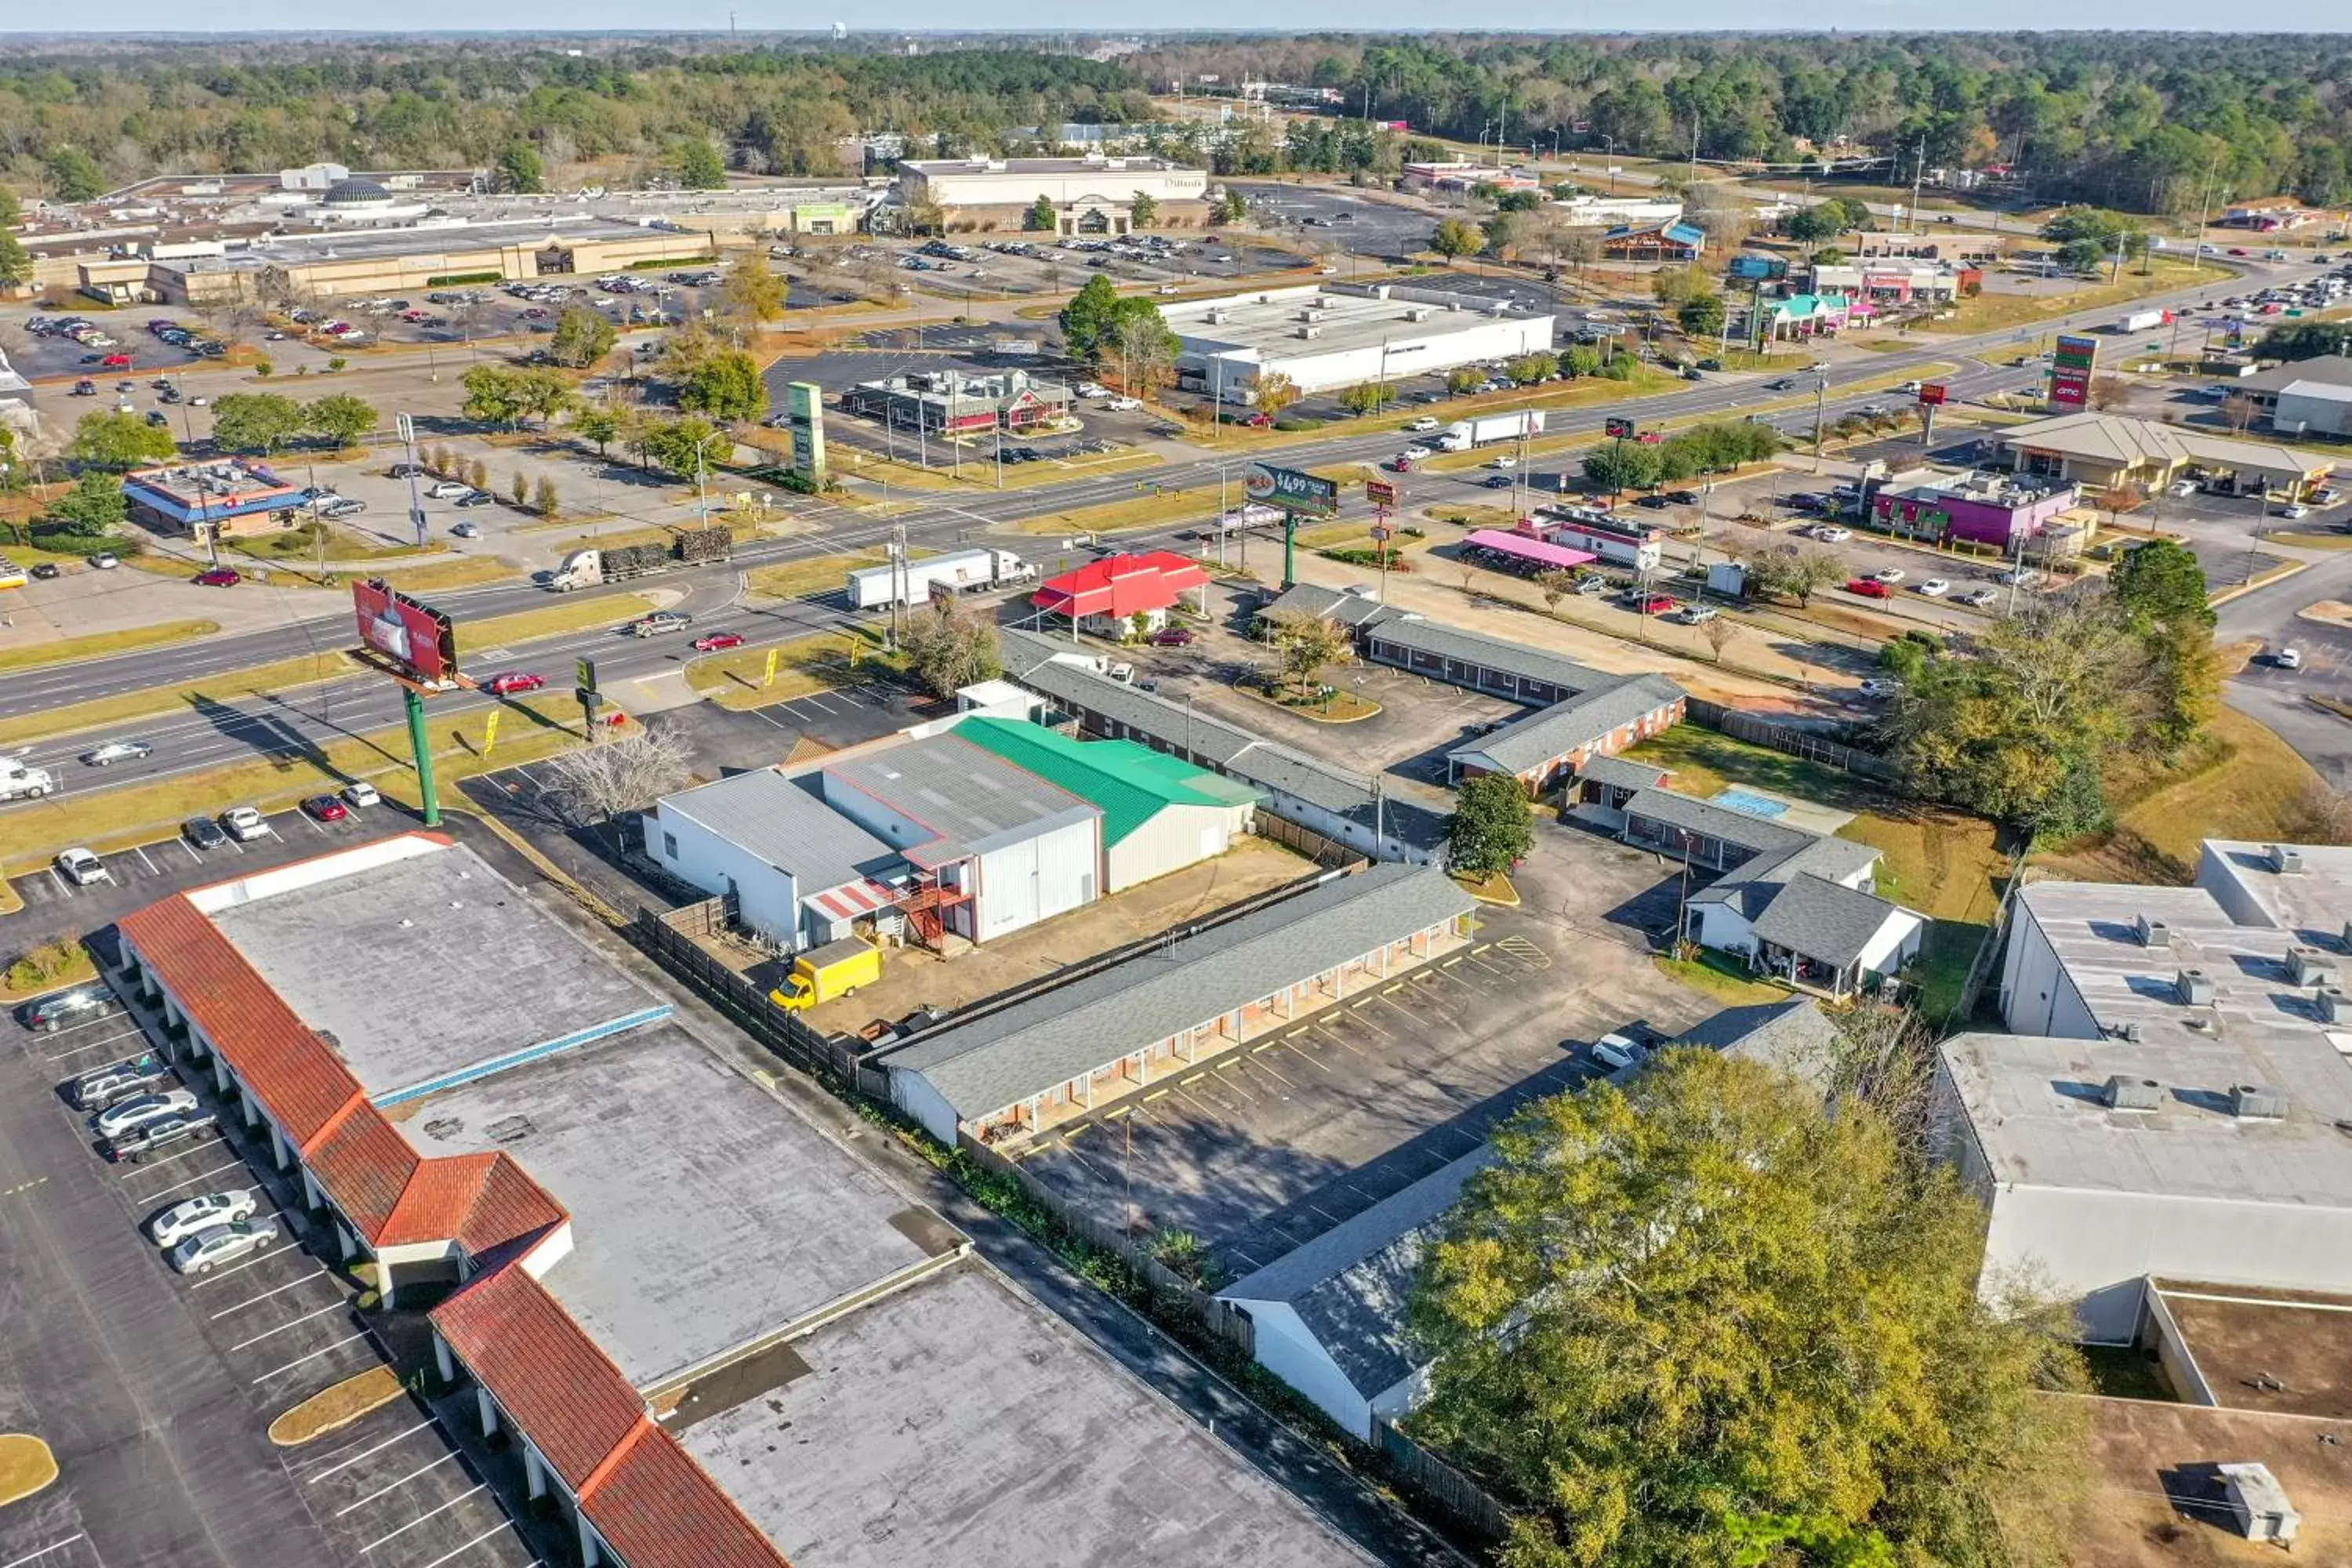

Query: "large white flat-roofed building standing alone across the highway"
(1160, 285), (1552, 402)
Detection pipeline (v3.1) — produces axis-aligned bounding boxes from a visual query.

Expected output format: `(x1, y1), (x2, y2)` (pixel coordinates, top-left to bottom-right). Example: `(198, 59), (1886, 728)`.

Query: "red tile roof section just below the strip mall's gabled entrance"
(433, 1262), (654, 1495)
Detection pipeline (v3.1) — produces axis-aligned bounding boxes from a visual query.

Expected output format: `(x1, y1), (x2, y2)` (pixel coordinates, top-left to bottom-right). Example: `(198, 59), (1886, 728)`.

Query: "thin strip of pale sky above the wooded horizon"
(13, 0), (2352, 35)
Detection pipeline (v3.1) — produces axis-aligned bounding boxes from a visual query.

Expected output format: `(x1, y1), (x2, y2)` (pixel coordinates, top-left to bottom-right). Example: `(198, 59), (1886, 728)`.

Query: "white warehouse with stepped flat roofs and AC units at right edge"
(1936, 839), (2352, 1345)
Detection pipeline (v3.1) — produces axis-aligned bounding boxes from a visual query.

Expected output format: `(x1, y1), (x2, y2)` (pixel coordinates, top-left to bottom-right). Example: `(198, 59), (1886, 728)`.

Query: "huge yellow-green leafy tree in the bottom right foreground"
(1409, 1048), (2086, 1568)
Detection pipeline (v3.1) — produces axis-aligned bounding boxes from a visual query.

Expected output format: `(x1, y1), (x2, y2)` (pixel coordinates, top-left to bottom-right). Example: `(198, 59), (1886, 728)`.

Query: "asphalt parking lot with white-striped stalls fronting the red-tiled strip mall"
(0, 982), (534, 1568)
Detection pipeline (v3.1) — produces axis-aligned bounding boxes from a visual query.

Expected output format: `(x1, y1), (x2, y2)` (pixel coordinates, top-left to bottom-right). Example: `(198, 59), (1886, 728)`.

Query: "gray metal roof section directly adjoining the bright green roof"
(811, 731), (1103, 865)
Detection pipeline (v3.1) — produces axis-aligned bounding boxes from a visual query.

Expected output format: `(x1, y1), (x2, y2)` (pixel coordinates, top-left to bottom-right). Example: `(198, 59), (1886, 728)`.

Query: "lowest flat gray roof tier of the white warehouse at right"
(1943, 1029), (2352, 1208)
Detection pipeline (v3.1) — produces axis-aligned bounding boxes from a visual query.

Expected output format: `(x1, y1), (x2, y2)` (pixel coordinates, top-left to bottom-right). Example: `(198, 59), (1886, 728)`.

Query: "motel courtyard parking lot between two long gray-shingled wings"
(1025, 825), (1712, 1276)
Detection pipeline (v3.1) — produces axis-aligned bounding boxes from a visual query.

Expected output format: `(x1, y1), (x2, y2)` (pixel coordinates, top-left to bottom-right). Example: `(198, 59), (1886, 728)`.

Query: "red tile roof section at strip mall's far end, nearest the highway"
(120, 895), (365, 1152)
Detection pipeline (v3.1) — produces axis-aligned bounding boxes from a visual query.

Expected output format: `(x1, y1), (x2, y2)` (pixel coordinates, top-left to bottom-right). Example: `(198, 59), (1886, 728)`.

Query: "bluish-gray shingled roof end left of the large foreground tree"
(1218, 1145), (1494, 1399)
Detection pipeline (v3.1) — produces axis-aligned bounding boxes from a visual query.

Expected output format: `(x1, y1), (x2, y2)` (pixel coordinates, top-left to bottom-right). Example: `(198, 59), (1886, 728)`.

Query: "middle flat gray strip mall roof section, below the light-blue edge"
(395, 1025), (938, 1389)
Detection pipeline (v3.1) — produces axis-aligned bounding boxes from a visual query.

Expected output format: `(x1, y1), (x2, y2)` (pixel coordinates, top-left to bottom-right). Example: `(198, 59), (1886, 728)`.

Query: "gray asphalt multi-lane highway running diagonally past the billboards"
(0, 251), (2314, 818)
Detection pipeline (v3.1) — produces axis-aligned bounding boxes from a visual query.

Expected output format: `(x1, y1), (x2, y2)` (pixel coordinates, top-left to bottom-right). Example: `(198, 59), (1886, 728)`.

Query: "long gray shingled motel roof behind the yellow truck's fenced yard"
(880, 865), (1472, 1121)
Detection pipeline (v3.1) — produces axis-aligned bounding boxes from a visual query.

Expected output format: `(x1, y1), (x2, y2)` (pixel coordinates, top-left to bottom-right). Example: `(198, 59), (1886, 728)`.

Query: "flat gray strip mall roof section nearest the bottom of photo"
(677, 1260), (1374, 1568)
